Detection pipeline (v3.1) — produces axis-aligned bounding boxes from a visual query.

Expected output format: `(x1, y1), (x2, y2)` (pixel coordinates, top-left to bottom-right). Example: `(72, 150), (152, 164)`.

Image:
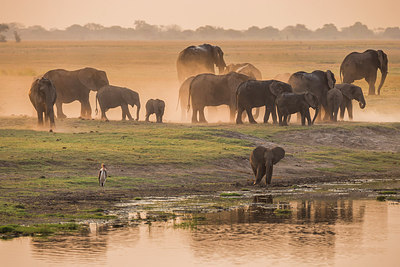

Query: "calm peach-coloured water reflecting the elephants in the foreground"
(0, 197), (400, 266)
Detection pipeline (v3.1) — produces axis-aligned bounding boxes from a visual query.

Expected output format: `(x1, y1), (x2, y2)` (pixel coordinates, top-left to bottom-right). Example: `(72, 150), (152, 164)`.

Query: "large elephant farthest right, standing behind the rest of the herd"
(340, 49), (388, 95)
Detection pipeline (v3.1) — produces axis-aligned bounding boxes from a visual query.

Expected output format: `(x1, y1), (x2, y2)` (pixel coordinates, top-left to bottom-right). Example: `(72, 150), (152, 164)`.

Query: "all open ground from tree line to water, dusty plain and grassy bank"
(0, 41), (400, 231)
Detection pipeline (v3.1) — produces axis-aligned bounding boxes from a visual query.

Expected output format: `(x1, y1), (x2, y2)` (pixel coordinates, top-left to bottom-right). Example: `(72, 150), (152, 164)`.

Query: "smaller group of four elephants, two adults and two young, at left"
(29, 68), (165, 128)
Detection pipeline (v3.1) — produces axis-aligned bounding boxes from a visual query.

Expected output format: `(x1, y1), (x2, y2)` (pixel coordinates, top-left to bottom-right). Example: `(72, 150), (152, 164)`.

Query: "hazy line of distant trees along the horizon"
(0, 20), (400, 42)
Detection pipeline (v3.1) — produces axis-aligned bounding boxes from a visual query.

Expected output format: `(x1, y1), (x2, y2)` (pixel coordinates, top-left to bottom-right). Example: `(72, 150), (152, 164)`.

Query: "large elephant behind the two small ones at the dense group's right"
(289, 70), (336, 120)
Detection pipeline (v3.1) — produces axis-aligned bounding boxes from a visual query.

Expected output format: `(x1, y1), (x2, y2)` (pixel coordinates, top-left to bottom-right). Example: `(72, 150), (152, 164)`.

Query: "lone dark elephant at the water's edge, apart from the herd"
(250, 146), (285, 185)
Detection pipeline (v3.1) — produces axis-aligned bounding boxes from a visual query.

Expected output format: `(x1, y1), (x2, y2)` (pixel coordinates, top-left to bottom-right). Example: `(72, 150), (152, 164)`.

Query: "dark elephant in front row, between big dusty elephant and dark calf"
(236, 80), (293, 124)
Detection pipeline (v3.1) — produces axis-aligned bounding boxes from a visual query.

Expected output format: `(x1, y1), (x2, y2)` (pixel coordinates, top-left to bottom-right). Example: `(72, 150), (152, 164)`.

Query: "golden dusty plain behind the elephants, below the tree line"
(0, 41), (400, 126)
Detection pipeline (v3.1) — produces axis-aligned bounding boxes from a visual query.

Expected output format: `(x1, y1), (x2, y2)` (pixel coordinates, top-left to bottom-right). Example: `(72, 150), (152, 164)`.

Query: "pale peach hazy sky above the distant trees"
(0, 0), (400, 29)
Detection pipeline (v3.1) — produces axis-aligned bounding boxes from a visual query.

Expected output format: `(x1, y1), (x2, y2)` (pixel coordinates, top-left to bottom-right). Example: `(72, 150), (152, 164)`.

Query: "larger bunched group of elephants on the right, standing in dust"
(177, 44), (388, 126)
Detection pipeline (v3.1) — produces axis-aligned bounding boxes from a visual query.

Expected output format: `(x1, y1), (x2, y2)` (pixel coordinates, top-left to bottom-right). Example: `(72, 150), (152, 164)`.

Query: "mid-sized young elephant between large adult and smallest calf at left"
(96, 85), (140, 121)
